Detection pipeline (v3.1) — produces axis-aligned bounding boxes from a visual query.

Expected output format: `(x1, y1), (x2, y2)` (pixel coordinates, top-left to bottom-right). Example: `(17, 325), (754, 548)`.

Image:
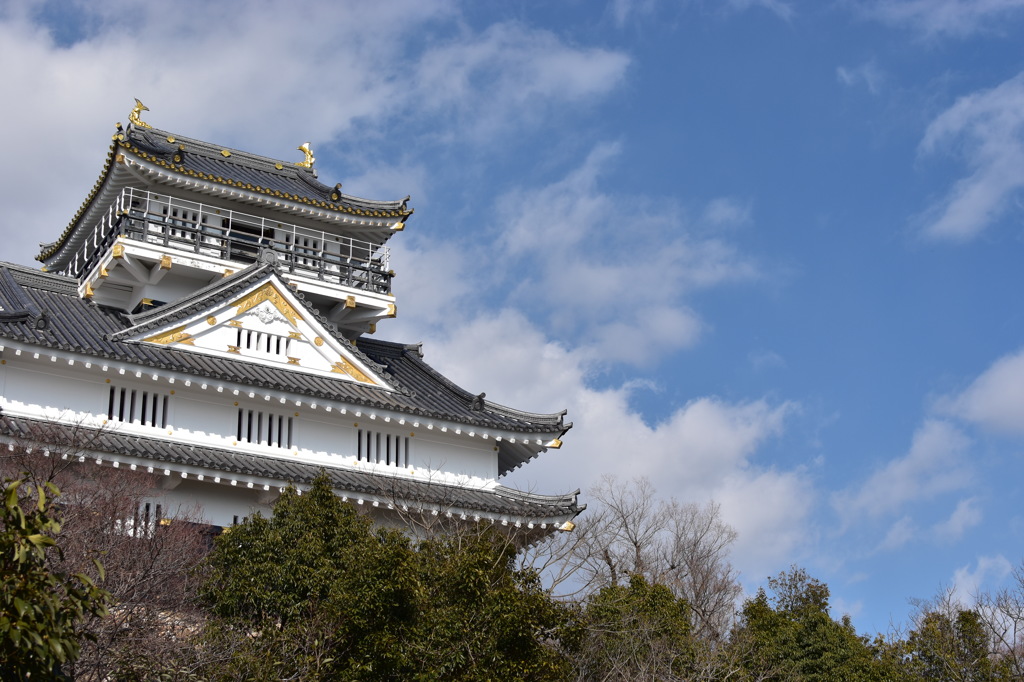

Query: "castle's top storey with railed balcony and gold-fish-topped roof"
(37, 100), (413, 339)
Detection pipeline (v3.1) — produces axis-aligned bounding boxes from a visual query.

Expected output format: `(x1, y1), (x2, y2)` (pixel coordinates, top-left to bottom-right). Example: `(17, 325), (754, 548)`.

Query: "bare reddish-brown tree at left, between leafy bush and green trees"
(0, 429), (209, 680)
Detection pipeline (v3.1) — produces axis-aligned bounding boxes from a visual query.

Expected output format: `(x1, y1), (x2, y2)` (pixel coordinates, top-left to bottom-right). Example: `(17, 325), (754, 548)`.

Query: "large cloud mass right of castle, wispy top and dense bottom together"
(389, 144), (802, 576)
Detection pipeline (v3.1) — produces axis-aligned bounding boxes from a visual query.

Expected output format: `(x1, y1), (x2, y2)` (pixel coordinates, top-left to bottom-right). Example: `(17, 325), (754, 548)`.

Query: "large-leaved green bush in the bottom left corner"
(0, 480), (109, 679)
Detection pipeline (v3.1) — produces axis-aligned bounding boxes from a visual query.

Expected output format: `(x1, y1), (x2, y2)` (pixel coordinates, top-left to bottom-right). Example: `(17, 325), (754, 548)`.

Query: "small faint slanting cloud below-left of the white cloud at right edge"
(833, 419), (971, 525)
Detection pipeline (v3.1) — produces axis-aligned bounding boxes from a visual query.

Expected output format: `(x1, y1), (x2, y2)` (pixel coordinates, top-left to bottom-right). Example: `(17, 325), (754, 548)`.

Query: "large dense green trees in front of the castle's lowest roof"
(198, 474), (566, 680)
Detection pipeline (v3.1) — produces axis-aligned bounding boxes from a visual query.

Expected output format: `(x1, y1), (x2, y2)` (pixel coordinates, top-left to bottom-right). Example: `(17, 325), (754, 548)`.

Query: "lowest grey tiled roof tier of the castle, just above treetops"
(0, 414), (585, 522)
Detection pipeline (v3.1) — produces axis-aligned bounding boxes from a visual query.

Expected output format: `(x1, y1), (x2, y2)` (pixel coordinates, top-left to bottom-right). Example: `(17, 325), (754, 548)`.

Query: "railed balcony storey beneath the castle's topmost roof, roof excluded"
(71, 187), (396, 338)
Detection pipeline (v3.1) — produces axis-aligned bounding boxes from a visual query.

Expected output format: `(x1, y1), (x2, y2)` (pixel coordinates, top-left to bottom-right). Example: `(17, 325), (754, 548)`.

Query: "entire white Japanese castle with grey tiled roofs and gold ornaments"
(0, 100), (582, 541)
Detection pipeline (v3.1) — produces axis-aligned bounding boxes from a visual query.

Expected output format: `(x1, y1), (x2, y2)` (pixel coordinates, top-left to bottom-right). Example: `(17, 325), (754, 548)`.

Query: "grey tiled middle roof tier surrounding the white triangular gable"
(0, 263), (571, 446)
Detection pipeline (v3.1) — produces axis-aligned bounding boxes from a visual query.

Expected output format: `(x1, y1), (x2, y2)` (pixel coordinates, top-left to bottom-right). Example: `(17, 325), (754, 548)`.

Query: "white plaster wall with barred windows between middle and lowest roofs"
(2, 354), (498, 484)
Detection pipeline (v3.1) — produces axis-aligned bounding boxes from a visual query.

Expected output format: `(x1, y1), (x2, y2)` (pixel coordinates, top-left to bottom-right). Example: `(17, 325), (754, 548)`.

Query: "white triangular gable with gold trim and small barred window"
(123, 272), (390, 388)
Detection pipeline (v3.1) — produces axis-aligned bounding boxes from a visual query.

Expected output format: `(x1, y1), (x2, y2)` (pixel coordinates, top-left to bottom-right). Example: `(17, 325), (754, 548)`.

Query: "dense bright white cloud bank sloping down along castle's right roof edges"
(387, 199), (802, 577)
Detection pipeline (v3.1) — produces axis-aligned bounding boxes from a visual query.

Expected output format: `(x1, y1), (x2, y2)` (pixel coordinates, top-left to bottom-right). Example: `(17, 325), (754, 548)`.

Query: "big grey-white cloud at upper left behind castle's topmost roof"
(0, 0), (629, 261)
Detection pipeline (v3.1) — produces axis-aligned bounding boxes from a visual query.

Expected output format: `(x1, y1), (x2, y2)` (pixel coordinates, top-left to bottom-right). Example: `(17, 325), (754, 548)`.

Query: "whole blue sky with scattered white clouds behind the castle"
(0, 0), (1024, 633)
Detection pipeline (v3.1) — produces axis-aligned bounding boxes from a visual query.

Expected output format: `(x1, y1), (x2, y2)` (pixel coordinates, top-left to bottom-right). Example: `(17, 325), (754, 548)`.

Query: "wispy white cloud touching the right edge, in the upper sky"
(921, 73), (1024, 242)
